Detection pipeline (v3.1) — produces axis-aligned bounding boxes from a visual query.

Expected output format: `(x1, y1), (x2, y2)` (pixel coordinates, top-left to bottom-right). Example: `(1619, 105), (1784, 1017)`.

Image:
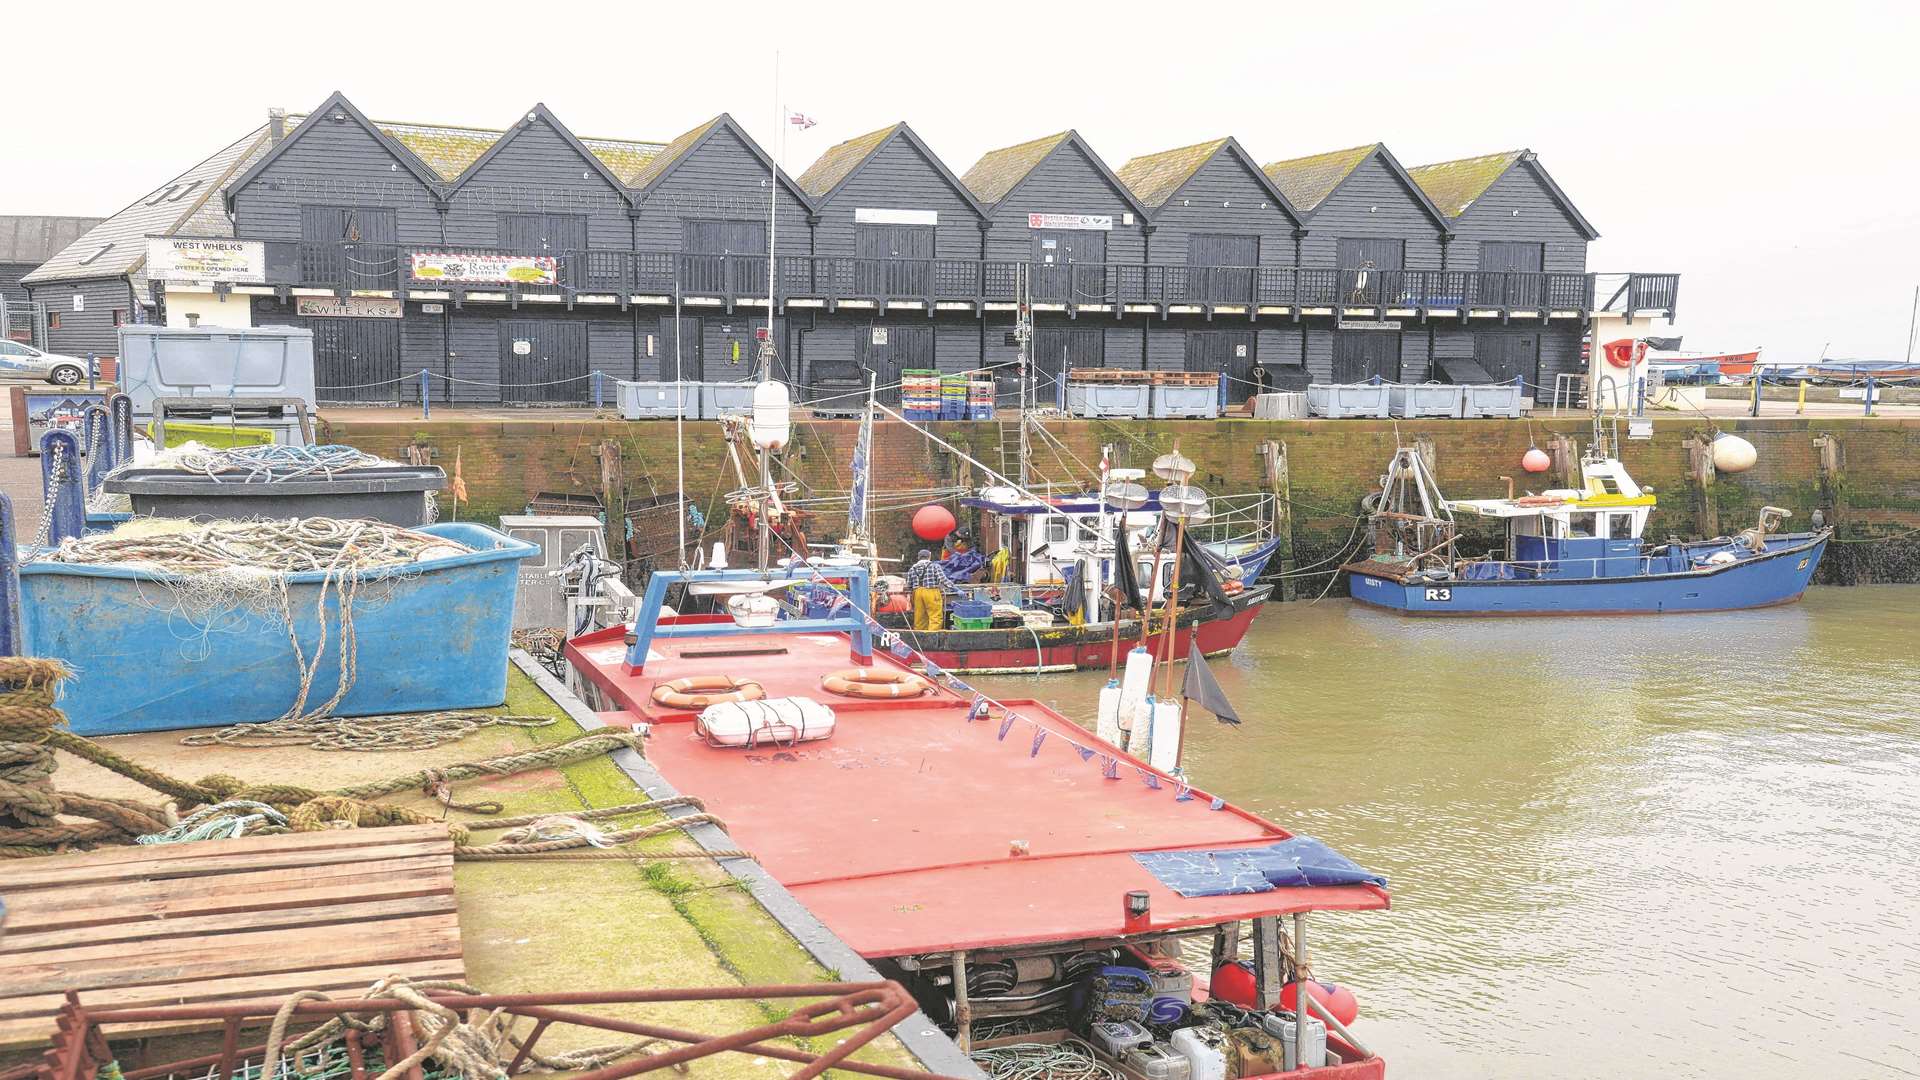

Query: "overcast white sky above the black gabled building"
(0, 0), (1920, 359)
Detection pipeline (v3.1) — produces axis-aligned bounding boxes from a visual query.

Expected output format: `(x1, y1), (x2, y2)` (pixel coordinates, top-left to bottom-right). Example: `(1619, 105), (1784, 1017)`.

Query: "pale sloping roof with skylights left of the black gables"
(23, 125), (267, 284)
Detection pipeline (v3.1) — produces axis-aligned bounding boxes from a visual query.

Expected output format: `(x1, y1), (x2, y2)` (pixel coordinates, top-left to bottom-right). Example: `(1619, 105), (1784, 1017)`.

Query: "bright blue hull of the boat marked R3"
(1350, 534), (1828, 617)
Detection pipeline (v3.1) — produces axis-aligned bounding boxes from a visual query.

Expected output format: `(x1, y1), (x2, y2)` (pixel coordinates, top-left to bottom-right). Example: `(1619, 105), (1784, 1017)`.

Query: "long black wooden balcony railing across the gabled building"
(243, 240), (1680, 317)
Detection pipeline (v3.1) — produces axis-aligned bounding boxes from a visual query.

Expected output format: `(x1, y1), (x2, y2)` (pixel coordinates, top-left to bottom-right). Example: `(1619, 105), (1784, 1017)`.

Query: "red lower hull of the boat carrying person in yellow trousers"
(897, 586), (1269, 675)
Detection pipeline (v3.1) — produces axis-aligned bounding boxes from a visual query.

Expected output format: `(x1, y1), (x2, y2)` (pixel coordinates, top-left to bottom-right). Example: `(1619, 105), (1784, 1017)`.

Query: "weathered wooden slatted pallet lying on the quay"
(0, 824), (465, 1049)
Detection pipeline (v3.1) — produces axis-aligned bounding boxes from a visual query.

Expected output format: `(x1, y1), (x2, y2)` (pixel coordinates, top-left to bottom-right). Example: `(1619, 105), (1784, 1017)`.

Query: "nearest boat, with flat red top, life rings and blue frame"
(566, 567), (1388, 1080)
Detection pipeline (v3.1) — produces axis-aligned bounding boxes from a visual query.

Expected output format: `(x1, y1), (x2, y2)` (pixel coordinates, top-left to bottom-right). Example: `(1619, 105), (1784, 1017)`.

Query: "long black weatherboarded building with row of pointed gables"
(37, 94), (1676, 402)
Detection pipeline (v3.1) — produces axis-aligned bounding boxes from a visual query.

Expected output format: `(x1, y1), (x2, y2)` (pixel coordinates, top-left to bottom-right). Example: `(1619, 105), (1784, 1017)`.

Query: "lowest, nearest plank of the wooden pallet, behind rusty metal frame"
(0, 961), (467, 1049)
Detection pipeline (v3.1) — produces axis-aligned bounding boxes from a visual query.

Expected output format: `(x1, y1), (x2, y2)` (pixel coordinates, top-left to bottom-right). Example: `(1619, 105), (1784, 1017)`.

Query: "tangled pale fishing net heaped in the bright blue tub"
(50, 517), (470, 719)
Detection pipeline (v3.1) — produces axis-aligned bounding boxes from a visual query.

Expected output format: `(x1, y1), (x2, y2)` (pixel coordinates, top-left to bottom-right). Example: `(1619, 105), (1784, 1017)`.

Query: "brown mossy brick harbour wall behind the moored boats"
(324, 413), (1920, 596)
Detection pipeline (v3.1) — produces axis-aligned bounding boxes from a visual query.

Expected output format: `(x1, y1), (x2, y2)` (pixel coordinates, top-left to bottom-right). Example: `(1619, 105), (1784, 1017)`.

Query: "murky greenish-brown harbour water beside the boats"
(979, 586), (1920, 1078)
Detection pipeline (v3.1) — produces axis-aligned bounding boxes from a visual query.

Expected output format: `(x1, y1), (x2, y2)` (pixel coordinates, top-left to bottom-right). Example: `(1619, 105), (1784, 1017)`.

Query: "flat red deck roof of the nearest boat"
(566, 626), (1388, 957)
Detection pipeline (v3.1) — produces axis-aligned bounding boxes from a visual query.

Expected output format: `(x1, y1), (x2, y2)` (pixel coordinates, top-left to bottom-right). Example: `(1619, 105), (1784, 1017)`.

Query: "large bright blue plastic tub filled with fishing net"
(19, 523), (540, 734)
